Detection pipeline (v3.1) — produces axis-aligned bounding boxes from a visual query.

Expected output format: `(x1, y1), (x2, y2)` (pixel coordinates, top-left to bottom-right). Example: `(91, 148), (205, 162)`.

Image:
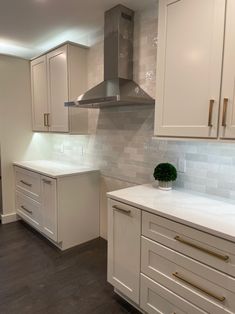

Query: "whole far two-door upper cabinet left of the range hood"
(31, 44), (89, 134)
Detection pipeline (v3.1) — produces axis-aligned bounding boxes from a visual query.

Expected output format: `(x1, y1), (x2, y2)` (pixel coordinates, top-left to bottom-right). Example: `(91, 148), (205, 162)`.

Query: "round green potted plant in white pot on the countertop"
(153, 163), (177, 190)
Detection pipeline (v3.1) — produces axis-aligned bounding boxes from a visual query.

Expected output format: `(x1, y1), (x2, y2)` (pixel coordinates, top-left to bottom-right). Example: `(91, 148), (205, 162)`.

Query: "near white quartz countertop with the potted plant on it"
(107, 184), (235, 242)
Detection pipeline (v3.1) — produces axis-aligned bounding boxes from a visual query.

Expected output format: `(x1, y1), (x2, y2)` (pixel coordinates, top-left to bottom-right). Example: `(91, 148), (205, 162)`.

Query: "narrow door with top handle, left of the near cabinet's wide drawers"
(108, 200), (141, 304)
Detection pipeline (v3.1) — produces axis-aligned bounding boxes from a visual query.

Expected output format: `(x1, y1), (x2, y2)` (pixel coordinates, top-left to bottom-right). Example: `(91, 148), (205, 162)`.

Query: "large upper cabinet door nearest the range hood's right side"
(155, 0), (226, 138)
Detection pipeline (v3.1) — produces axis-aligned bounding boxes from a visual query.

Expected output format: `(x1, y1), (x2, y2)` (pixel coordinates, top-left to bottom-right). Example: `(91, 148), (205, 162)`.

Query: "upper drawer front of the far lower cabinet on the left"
(15, 167), (41, 201)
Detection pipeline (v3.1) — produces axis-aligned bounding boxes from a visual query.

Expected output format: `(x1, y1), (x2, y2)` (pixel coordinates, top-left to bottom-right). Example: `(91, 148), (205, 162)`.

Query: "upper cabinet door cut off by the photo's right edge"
(220, 0), (235, 139)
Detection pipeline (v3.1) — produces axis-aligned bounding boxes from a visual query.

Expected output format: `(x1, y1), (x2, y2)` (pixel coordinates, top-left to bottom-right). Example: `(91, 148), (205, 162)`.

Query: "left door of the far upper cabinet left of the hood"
(31, 56), (48, 131)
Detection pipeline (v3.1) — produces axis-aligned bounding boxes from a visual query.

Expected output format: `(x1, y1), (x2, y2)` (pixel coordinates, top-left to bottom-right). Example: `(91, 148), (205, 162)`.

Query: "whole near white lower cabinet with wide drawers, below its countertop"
(108, 198), (235, 314)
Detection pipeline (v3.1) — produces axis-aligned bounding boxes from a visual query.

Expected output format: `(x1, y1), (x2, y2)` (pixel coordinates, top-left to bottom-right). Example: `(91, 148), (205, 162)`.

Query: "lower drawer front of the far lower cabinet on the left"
(16, 191), (42, 230)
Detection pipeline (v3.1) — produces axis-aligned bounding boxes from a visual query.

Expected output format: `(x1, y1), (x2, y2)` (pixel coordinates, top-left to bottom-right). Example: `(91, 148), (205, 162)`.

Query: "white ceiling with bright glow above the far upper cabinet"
(0, 0), (156, 59)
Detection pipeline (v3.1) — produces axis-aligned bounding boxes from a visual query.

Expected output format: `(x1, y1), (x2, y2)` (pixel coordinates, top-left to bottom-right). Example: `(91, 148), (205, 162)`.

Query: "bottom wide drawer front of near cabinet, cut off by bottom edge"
(140, 274), (207, 314)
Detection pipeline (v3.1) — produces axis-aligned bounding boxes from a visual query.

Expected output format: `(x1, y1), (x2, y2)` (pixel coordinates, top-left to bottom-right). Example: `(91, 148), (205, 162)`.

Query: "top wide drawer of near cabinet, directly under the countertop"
(142, 212), (235, 277)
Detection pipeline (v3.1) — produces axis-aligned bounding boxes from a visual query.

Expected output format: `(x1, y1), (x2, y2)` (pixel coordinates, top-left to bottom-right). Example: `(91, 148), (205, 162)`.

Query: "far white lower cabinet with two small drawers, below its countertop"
(15, 166), (99, 250)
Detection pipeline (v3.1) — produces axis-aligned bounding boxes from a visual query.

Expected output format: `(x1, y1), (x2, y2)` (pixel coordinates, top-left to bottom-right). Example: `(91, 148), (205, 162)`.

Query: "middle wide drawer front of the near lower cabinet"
(141, 237), (235, 314)
